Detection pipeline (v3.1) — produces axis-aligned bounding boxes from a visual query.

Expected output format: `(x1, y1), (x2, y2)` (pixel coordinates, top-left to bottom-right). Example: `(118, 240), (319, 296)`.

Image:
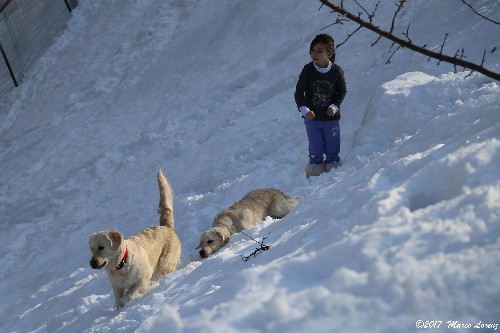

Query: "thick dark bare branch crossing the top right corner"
(320, 0), (500, 81)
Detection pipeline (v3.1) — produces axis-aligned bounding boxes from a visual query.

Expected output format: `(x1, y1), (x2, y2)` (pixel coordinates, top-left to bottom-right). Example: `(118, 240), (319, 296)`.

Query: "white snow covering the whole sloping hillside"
(0, 0), (500, 333)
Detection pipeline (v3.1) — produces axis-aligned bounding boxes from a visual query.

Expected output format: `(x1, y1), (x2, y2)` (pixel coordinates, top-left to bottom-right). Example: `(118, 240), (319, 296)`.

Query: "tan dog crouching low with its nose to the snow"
(196, 188), (300, 258)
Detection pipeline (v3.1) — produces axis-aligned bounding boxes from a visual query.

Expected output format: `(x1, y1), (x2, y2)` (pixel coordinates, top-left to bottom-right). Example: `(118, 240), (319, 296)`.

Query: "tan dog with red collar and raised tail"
(89, 170), (181, 308)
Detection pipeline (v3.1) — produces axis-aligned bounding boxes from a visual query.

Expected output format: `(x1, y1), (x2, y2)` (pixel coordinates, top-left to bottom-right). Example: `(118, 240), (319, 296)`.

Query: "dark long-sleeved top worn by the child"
(295, 62), (347, 121)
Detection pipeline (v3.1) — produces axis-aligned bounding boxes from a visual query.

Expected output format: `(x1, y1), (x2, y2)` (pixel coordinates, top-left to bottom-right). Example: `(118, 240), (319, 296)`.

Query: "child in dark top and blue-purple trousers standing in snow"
(295, 34), (347, 178)
